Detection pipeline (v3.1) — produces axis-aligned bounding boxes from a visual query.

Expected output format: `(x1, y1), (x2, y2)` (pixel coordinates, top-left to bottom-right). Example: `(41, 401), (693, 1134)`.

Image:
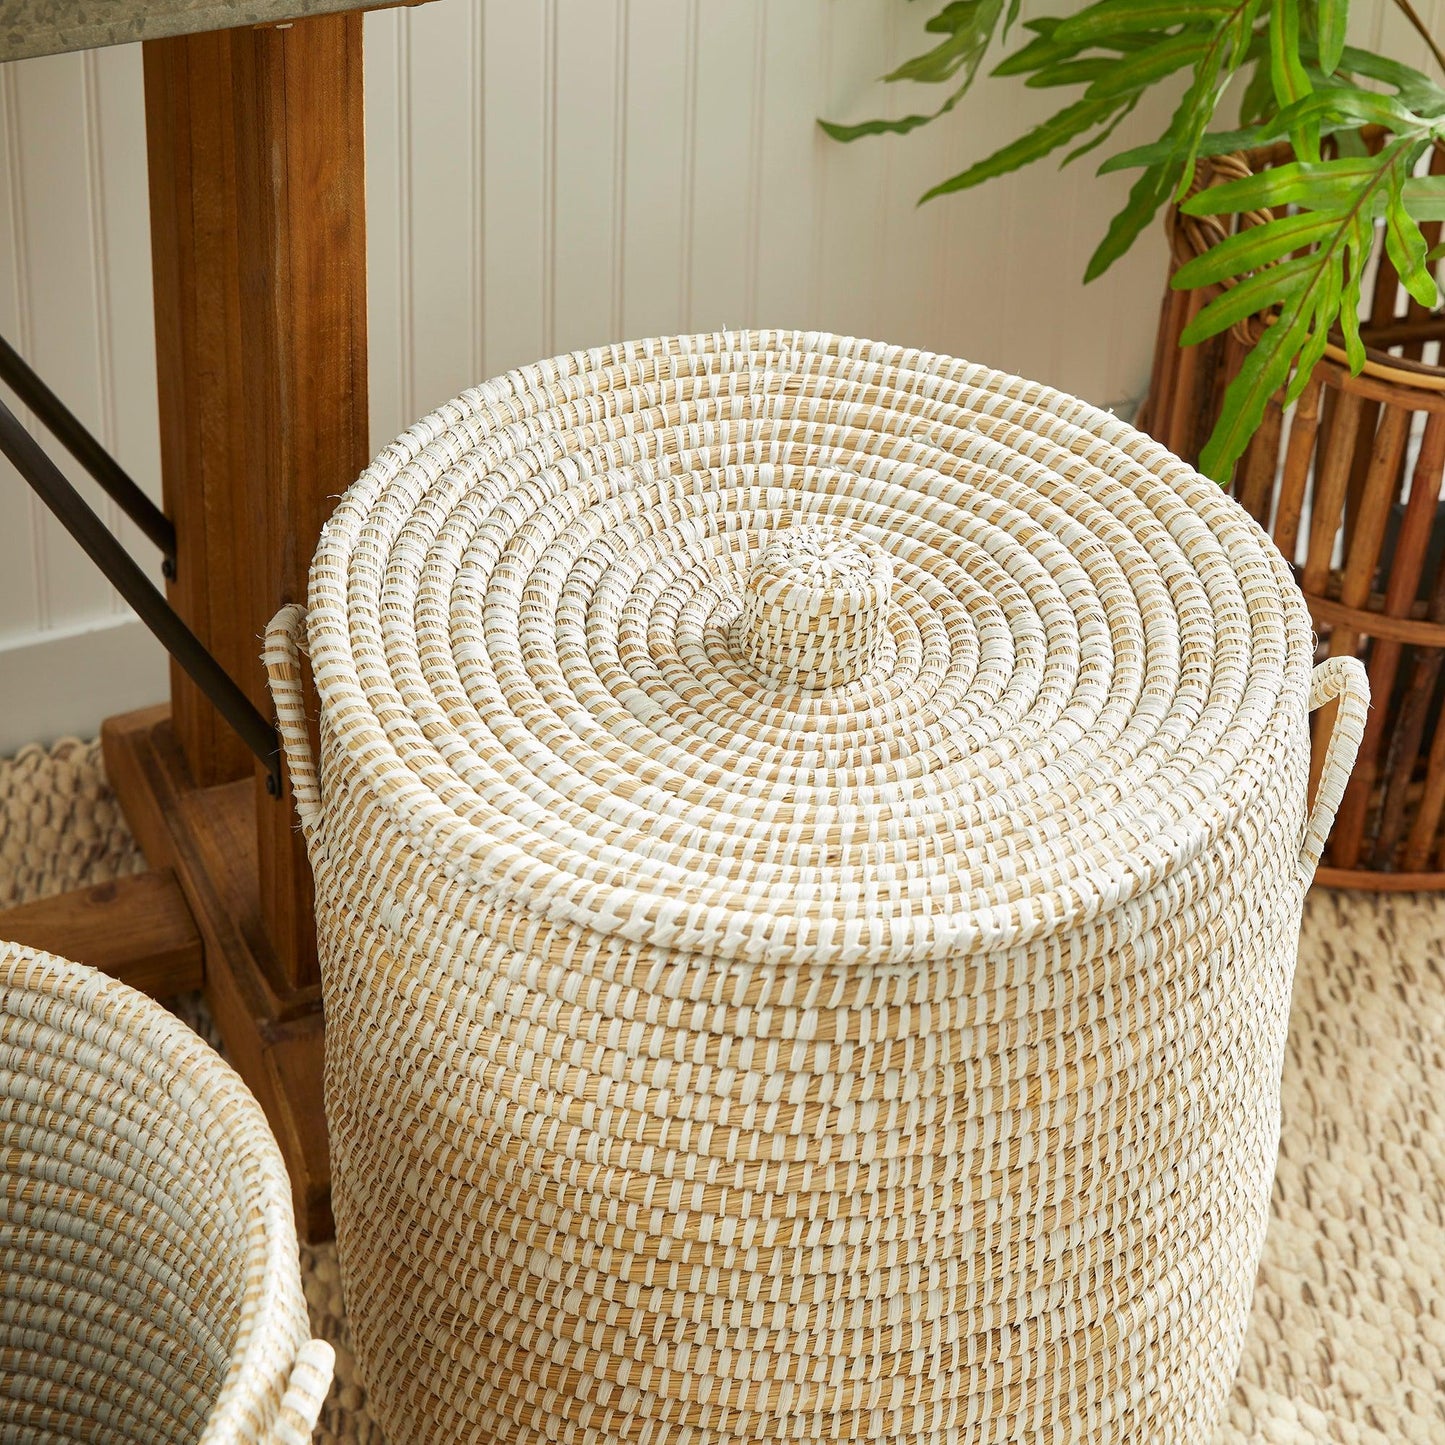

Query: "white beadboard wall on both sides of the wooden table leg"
(0, 0), (1421, 754)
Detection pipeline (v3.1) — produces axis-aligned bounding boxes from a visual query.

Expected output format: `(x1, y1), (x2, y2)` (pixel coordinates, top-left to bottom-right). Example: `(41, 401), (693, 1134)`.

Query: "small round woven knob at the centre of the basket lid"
(738, 526), (893, 691)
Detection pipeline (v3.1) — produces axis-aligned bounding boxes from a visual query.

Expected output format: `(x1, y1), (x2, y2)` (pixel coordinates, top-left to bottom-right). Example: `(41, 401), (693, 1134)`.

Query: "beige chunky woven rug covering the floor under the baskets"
(0, 741), (1445, 1445)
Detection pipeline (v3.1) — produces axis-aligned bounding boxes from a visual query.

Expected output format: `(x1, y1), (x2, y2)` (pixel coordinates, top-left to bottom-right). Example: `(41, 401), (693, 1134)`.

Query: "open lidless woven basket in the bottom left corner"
(0, 944), (332, 1445)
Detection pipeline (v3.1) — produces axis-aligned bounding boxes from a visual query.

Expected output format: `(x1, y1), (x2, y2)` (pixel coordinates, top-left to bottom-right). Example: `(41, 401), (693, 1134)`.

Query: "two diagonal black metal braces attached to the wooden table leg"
(0, 338), (280, 798)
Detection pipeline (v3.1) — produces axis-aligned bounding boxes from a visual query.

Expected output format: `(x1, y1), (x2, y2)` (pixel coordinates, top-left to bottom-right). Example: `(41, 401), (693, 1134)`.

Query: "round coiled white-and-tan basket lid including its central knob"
(309, 332), (1311, 962)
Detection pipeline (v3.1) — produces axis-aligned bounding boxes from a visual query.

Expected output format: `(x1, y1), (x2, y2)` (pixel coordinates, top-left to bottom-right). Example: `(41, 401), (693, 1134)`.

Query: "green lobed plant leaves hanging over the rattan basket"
(821, 0), (1445, 481)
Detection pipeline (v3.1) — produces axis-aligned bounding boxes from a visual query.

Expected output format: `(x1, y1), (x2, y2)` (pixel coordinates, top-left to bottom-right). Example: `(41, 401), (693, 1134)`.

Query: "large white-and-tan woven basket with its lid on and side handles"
(267, 332), (1366, 1445)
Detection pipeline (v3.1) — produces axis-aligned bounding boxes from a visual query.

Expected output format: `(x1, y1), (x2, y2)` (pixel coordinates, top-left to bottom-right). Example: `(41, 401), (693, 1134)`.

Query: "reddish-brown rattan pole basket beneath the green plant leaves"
(1139, 146), (1445, 889)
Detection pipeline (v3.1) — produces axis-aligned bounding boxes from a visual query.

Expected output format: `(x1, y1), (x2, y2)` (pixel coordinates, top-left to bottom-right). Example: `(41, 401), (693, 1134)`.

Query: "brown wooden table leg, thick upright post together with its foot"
(104, 14), (368, 1238)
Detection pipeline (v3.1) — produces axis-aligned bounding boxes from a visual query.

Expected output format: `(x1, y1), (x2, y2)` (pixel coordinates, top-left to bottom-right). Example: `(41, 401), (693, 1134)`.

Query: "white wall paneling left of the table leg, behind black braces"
(0, 48), (166, 751)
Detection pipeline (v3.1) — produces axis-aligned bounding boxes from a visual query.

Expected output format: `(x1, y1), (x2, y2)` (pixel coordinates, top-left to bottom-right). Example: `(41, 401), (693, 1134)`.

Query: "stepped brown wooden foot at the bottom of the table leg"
(101, 707), (332, 1241)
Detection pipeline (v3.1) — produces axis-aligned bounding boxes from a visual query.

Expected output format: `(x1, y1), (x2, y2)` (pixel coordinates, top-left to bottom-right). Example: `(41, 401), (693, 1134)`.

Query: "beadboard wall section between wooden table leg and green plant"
(367, 0), (1162, 445)
